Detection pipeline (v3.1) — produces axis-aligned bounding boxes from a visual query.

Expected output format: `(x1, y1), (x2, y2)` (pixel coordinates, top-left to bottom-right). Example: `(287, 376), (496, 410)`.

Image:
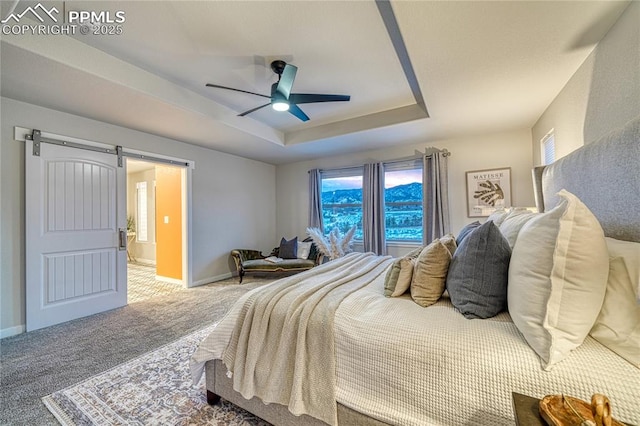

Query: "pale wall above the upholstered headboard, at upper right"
(532, 1), (640, 164)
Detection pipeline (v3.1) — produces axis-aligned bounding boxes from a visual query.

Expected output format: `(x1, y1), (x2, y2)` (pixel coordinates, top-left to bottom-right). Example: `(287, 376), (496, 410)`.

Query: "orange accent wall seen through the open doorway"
(156, 166), (182, 280)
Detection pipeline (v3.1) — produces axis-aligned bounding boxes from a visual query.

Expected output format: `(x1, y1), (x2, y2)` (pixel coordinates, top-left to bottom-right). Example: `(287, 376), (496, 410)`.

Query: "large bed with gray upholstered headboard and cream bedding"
(191, 117), (640, 425)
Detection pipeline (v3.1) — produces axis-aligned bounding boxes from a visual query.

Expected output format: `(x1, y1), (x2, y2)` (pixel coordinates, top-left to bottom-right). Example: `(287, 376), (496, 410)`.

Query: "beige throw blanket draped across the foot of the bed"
(223, 253), (392, 425)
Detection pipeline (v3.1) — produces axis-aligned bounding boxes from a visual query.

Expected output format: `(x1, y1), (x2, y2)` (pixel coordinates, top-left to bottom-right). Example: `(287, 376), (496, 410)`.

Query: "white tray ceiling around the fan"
(0, 0), (629, 164)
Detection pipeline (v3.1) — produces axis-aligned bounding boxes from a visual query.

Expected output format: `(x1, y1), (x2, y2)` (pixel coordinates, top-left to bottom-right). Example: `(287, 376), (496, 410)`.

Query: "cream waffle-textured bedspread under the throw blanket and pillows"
(192, 256), (640, 426)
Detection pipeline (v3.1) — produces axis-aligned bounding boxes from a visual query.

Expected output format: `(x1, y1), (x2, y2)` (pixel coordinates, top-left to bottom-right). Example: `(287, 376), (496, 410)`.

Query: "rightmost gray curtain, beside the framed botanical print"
(422, 152), (451, 244)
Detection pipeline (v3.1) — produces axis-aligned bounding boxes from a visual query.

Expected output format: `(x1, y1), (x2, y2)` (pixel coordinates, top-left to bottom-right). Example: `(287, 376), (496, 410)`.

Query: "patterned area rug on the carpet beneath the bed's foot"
(42, 326), (269, 426)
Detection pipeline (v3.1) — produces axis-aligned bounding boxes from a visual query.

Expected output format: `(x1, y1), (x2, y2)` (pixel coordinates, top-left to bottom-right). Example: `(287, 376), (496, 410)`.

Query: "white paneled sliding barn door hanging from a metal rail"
(25, 141), (127, 331)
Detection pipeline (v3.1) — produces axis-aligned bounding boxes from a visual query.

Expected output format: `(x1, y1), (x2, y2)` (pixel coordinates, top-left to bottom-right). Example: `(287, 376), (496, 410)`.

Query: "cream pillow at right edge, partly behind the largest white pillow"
(591, 238), (640, 368)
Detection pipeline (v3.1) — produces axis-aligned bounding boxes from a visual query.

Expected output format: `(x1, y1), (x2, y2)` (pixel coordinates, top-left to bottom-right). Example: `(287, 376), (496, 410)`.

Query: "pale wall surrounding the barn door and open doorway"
(0, 98), (276, 336)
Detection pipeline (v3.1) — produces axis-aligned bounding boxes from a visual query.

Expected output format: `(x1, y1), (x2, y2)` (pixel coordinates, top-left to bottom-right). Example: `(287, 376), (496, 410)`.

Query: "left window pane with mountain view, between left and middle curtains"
(322, 167), (362, 240)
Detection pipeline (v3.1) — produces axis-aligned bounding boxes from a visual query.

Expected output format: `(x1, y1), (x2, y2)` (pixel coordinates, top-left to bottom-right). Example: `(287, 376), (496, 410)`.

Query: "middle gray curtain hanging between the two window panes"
(362, 163), (387, 255)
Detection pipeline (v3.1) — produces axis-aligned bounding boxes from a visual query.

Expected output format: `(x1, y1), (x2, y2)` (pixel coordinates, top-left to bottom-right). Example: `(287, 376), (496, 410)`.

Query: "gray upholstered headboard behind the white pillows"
(533, 117), (640, 242)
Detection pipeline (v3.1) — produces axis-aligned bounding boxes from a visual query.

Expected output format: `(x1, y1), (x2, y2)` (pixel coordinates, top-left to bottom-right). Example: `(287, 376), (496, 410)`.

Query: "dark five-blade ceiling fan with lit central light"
(207, 60), (351, 121)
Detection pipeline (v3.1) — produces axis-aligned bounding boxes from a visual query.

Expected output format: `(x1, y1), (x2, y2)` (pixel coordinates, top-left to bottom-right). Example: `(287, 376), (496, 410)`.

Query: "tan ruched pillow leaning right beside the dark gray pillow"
(411, 236), (455, 307)
